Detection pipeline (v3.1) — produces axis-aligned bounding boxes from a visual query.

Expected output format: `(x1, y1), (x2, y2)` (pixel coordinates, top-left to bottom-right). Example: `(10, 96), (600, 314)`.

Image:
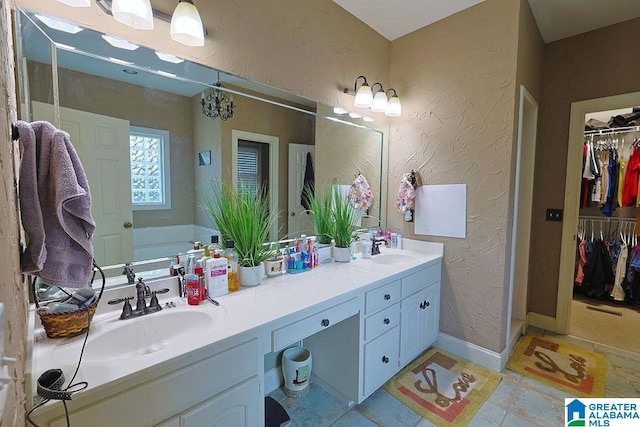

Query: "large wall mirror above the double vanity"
(16, 9), (388, 280)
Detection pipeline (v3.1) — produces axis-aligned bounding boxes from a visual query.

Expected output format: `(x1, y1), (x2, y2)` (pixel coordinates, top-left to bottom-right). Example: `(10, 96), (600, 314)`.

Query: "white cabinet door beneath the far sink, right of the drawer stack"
(400, 284), (440, 366)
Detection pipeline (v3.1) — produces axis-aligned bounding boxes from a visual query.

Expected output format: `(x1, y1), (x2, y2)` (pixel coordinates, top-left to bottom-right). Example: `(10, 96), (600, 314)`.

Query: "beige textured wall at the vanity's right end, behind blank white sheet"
(388, 0), (519, 352)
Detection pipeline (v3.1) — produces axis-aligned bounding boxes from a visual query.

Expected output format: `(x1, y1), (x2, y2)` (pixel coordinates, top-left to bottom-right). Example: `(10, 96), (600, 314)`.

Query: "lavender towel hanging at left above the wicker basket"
(17, 121), (95, 288)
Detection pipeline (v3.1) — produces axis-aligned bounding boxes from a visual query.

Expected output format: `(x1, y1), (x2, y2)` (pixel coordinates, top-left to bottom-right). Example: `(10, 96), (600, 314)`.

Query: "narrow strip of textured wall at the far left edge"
(0, 0), (27, 426)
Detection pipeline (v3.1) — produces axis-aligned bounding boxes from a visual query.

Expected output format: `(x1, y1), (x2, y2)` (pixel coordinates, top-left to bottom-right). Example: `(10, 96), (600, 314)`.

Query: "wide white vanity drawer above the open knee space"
(271, 298), (358, 351)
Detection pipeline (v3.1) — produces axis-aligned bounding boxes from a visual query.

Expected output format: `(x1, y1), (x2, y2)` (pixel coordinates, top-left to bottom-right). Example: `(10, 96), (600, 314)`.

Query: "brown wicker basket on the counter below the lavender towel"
(32, 262), (106, 338)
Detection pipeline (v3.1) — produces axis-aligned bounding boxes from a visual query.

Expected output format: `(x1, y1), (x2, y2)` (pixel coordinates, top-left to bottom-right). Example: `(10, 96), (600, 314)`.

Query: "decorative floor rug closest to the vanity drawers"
(384, 348), (502, 426)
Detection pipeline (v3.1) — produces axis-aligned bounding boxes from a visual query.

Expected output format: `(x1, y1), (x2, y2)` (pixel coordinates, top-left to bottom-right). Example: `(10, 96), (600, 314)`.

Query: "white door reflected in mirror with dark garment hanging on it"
(287, 144), (315, 236)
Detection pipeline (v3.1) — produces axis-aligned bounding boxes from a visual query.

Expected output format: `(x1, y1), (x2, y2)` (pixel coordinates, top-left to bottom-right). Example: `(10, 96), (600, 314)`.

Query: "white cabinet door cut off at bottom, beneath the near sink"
(180, 376), (264, 427)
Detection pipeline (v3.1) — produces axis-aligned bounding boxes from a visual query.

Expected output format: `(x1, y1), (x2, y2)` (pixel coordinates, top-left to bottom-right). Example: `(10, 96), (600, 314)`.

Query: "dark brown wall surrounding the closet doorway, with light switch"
(529, 19), (640, 317)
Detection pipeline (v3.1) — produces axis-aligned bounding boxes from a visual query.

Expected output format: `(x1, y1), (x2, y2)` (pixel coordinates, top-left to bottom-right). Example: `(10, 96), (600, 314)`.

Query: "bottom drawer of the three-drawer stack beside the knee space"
(364, 326), (400, 396)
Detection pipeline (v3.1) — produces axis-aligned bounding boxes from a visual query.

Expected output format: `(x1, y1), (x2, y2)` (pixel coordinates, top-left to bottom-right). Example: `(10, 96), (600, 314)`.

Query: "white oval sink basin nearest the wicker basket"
(53, 309), (224, 363)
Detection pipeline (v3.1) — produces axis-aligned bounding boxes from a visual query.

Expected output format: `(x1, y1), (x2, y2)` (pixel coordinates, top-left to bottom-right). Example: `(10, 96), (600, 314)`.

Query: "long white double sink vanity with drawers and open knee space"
(27, 239), (443, 427)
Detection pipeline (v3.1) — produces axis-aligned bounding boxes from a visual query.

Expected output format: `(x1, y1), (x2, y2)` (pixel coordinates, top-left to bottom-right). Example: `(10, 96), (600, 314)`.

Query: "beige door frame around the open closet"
(555, 92), (640, 354)
